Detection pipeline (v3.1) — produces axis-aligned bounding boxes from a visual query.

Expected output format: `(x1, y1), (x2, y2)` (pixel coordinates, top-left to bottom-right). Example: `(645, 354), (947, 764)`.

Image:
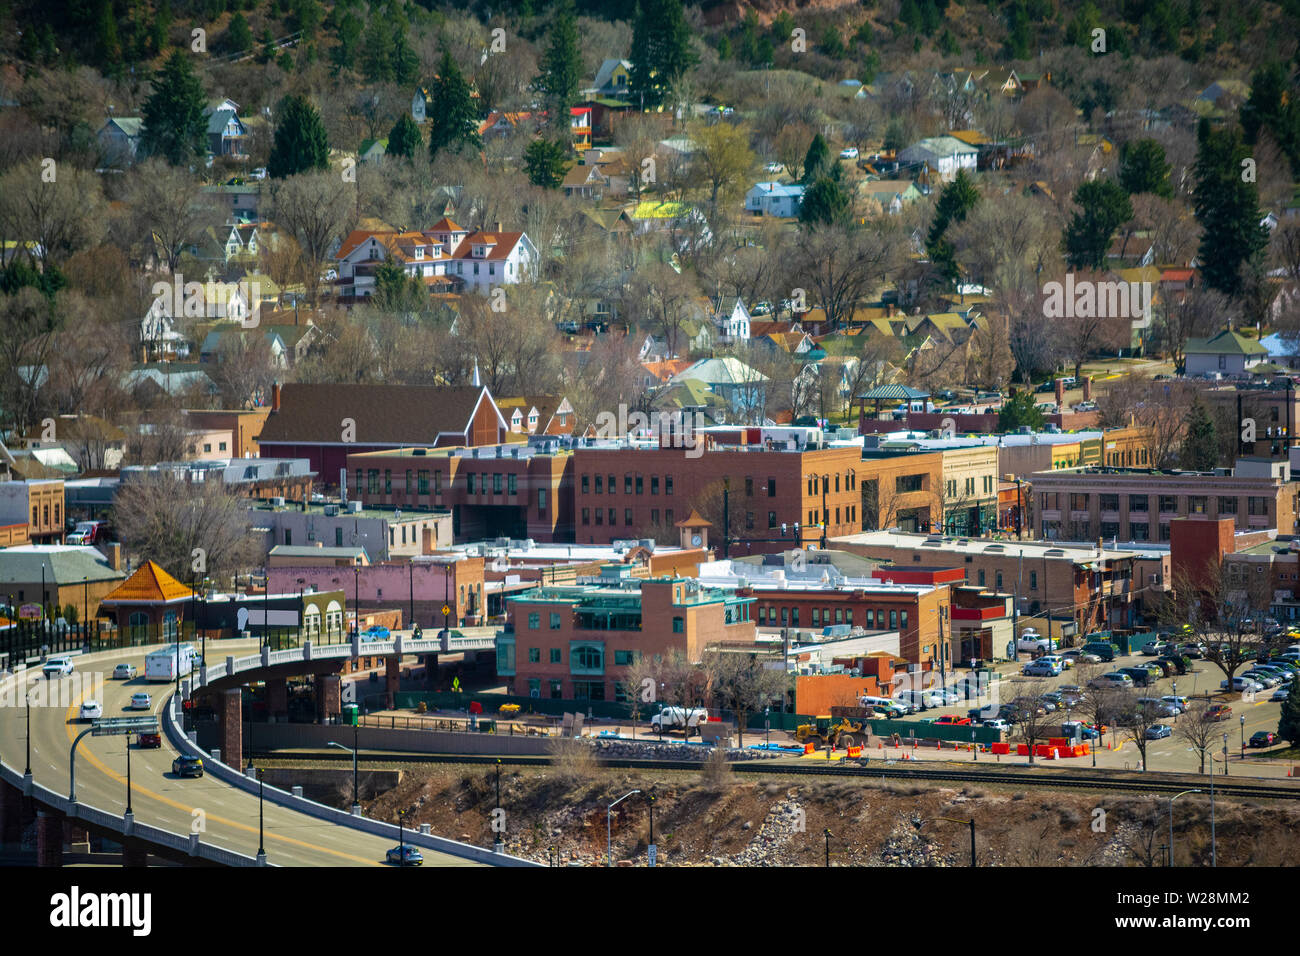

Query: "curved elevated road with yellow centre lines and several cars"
(0, 641), (478, 866)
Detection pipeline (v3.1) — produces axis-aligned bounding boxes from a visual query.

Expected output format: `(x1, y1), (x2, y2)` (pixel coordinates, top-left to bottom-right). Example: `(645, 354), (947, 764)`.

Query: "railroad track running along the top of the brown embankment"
(250, 750), (1300, 800)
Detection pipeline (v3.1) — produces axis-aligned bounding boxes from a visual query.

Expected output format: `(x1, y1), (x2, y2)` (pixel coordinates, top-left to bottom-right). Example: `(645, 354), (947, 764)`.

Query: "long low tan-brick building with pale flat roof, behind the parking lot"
(831, 531), (1144, 634)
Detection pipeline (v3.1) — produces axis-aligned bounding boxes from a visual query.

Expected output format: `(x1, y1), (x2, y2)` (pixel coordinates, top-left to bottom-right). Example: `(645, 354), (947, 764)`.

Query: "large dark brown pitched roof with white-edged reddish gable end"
(257, 385), (508, 497)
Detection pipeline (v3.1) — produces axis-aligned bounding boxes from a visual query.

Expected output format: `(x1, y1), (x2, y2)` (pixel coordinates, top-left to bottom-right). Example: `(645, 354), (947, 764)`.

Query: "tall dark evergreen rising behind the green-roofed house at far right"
(1192, 120), (1269, 295)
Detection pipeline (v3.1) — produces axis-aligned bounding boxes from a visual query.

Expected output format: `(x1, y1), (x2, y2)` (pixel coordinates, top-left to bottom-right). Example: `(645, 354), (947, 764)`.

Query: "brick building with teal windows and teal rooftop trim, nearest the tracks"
(497, 567), (754, 701)
